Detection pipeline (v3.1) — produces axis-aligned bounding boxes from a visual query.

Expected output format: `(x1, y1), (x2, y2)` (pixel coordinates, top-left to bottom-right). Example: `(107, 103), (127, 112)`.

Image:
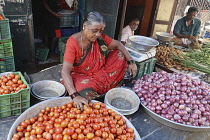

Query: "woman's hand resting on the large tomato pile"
(73, 96), (88, 111)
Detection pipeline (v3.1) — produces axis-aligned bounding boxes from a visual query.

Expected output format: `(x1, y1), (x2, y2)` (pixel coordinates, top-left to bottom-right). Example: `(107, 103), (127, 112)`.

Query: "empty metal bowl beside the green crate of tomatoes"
(32, 80), (66, 100)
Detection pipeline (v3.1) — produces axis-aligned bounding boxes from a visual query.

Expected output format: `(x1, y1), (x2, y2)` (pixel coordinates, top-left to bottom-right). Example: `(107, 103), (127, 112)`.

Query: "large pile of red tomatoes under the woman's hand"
(11, 102), (135, 140)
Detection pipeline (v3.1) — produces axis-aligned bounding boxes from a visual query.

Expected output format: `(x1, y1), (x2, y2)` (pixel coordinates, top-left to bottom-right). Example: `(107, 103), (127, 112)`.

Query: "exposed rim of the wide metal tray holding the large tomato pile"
(7, 97), (141, 140)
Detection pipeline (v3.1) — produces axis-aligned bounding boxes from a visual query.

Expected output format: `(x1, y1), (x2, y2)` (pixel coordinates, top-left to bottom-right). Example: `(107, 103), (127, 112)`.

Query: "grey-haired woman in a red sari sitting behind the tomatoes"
(62, 12), (137, 109)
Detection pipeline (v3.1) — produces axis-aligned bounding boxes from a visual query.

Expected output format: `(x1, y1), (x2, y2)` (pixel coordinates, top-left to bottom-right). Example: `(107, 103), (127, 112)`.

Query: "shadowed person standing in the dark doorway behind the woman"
(43, 0), (62, 58)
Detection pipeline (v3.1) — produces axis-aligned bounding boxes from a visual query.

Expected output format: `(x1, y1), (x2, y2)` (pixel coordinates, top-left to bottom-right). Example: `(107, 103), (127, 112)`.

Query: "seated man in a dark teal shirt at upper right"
(173, 7), (202, 48)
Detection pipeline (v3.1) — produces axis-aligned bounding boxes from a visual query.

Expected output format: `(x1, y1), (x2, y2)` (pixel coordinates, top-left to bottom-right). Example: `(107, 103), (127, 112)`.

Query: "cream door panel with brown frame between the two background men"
(150, 0), (178, 36)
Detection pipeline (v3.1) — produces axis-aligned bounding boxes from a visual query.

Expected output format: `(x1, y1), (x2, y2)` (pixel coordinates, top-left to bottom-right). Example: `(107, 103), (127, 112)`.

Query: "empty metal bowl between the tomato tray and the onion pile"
(104, 88), (140, 115)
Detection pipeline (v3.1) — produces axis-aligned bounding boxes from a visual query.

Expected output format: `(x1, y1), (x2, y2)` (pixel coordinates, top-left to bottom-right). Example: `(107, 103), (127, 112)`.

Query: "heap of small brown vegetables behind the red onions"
(155, 46), (193, 71)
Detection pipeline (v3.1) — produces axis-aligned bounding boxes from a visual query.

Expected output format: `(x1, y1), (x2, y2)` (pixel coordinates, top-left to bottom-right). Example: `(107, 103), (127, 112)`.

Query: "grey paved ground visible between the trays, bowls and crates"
(0, 65), (210, 140)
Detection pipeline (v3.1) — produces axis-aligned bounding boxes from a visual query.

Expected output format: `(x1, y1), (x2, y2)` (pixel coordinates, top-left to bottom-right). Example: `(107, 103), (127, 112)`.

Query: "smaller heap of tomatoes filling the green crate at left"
(0, 73), (27, 95)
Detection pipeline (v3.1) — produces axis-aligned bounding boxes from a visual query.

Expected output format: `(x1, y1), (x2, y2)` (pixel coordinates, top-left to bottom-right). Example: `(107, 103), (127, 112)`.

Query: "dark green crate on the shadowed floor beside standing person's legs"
(35, 44), (49, 61)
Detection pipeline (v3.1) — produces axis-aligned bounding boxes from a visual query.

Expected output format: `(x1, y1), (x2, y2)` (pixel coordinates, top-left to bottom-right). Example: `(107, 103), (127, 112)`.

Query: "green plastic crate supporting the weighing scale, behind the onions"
(134, 58), (156, 80)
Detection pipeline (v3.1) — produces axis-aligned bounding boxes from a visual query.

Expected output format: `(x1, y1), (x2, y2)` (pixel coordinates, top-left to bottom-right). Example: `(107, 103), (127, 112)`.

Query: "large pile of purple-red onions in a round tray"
(133, 71), (210, 126)
